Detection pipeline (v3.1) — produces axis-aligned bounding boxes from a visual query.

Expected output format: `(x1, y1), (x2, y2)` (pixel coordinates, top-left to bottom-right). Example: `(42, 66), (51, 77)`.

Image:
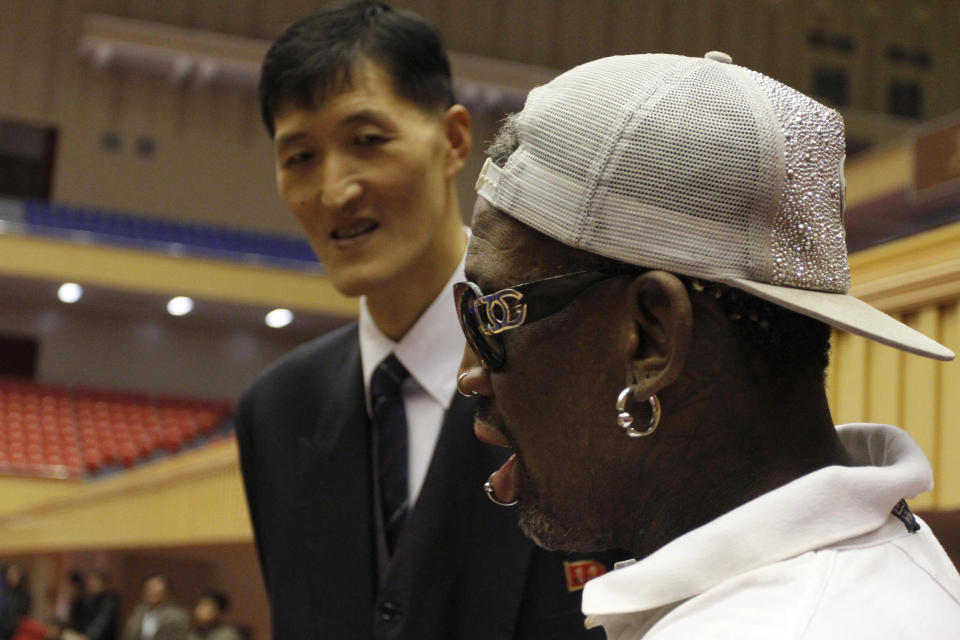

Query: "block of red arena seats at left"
(0, 378), (232, 477)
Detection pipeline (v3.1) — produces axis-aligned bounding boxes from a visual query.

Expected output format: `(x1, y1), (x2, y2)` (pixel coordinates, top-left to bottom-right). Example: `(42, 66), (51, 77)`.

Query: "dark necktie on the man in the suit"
(370, 354), (410, 555)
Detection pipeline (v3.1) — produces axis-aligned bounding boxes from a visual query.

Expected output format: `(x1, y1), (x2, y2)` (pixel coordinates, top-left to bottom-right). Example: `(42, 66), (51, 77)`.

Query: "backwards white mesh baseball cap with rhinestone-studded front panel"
(477, 52), (954, 360)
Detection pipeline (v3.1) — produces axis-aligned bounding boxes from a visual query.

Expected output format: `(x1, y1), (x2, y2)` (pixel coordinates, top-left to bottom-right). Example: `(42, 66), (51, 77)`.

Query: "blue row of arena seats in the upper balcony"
(18, 200), (318, 268)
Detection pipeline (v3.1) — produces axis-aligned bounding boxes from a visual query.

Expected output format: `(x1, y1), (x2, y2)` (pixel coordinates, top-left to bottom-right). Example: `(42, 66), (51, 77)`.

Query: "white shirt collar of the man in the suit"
(359, 227), (470, 413)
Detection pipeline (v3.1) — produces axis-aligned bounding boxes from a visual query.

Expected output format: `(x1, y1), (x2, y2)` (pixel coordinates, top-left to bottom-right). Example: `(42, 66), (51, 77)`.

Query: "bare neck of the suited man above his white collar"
(366, 215), (467, 340)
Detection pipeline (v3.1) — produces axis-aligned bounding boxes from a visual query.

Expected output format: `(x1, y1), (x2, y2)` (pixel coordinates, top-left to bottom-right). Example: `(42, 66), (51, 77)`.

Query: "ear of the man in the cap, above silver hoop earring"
(627, 271), (693, 395)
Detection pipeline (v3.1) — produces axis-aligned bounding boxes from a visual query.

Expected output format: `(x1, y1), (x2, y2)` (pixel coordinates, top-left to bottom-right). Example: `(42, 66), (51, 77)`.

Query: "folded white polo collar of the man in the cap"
(583, 424), (933, 622)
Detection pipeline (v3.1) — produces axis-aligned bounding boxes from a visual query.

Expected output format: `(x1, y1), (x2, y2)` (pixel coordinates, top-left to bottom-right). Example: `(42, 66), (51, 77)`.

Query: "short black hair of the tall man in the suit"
(259, 0), (456, 136)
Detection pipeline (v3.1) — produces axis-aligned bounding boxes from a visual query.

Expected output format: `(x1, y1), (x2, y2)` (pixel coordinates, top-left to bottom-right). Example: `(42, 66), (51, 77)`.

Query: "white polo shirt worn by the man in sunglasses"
(583, 424), (960, 640)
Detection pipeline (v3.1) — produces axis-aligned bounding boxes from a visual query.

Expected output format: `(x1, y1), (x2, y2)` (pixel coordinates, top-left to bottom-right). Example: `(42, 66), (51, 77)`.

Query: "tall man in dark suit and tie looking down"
(236, 2), (609, 640)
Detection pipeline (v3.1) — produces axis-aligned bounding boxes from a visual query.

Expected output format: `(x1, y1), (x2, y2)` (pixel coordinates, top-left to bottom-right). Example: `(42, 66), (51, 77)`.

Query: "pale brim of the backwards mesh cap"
(726, 278), (954, 360)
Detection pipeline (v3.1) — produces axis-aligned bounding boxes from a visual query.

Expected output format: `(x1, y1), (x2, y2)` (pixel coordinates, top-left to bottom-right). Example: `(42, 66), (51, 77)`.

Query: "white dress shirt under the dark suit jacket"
(360, 230), (469, 509)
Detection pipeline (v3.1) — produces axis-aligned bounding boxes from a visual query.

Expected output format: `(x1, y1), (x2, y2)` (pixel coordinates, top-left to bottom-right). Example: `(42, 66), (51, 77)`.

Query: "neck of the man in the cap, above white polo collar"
(629, 376), (852, 558)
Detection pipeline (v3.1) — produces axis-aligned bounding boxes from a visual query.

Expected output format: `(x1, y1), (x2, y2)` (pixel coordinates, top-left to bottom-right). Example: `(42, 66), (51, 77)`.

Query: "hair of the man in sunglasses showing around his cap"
(487, 114), (830, 380)
